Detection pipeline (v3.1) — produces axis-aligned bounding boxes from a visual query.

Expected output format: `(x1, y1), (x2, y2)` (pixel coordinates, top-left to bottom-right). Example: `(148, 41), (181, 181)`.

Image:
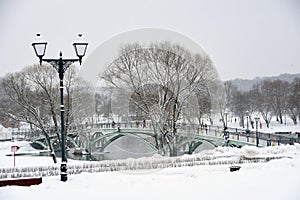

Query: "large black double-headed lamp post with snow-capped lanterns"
(32, 34), (88, 181)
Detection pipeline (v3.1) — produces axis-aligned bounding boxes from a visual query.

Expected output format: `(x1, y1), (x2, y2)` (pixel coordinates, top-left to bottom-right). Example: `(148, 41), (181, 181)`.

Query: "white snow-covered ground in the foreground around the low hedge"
(0, 142), (300, 200)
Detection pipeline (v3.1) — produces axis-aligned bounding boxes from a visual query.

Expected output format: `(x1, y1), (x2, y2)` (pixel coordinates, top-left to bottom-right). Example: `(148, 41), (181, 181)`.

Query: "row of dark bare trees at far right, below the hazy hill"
(225, 78), (300, 127)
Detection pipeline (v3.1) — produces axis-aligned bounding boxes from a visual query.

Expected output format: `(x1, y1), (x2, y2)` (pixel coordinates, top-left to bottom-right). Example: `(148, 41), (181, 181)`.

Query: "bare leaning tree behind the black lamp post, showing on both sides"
(0, 65), (92, 162)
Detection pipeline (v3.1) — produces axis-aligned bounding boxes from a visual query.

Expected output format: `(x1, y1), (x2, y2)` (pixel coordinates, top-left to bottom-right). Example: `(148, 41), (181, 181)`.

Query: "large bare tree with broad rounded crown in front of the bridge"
(101, 42), (218, 156)
